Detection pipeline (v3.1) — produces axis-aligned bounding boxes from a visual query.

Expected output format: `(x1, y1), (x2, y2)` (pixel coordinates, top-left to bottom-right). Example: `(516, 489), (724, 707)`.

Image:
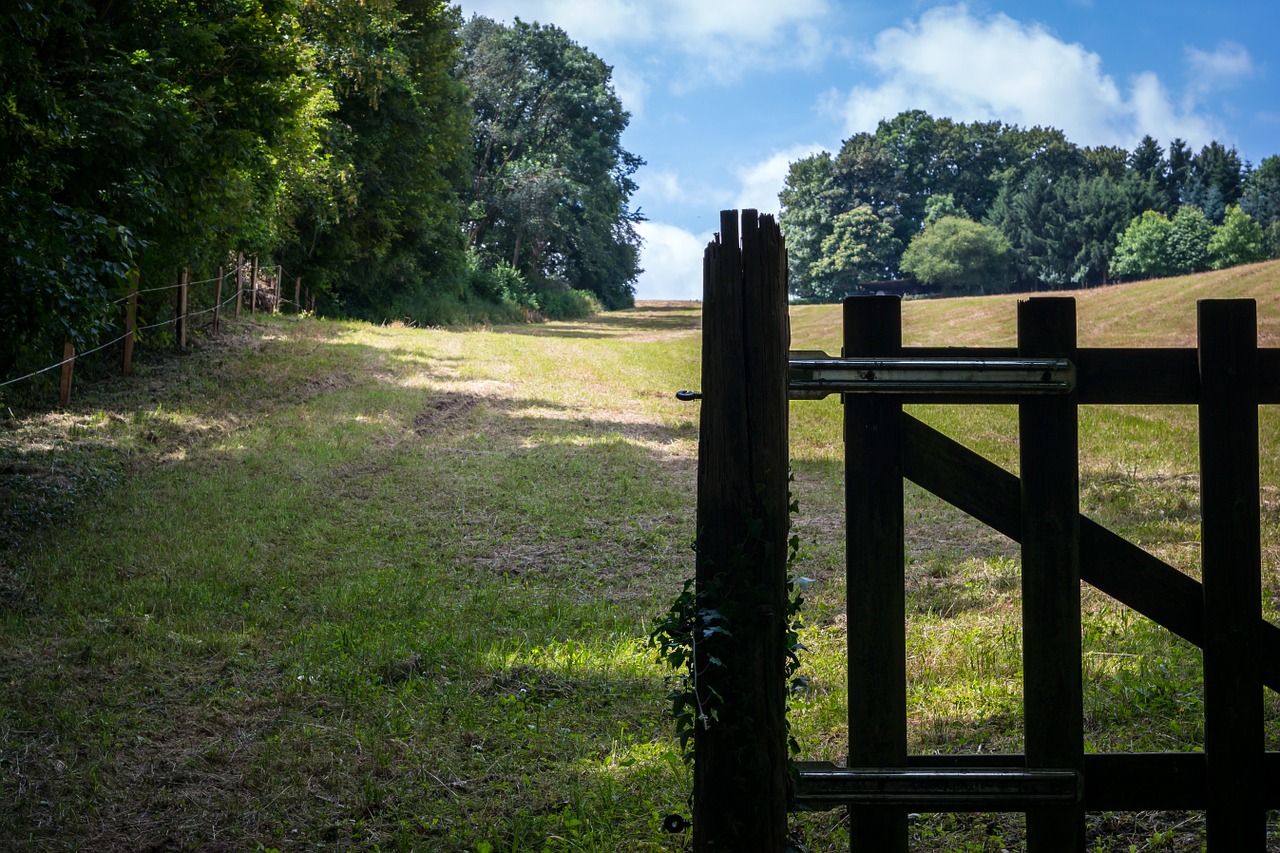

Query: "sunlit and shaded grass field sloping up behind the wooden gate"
(0, 264), (1280, 853)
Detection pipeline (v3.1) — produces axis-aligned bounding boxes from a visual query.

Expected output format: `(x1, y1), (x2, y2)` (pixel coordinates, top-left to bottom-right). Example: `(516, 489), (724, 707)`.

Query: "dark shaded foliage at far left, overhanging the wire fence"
(0, 0), (311, 368)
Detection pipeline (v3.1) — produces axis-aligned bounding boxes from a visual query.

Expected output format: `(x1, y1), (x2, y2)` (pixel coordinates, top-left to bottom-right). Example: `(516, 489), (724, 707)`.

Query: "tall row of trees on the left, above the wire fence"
(0, 0), (643, 375)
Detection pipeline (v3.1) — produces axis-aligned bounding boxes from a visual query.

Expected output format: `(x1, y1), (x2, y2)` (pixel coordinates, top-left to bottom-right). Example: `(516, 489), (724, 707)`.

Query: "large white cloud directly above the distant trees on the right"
(827, 5), (1231, 147)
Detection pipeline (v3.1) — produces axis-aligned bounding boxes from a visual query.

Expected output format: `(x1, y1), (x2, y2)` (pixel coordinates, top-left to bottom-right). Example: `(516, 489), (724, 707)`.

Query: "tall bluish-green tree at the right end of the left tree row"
(460, 17), (643, 307)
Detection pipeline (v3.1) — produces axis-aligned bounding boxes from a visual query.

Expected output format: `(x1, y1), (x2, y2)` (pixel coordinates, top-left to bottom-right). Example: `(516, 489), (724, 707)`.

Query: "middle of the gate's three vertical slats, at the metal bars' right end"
(1018, 297), (1084, 853)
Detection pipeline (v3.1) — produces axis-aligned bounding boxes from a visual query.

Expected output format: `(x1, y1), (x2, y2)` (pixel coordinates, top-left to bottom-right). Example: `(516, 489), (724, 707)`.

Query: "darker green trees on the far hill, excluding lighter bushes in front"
(780, 110), (1280, 298)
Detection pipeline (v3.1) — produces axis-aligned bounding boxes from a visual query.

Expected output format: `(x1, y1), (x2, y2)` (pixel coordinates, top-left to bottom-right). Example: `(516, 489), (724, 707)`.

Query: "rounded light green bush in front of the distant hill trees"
(902, 216), (1012, 295)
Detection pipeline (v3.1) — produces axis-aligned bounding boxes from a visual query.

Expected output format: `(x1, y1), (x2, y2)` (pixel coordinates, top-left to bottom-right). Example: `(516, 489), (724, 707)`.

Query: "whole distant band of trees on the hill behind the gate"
(780, 110), (1280, 300)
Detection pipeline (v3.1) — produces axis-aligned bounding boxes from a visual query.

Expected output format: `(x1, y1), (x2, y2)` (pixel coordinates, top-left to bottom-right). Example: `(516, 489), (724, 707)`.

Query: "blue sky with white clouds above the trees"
(460, 0), (1280, 300)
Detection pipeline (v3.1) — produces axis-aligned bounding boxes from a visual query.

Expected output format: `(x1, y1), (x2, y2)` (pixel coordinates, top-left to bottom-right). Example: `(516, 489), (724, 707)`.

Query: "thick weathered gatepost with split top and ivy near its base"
(694, 210), (790, 853)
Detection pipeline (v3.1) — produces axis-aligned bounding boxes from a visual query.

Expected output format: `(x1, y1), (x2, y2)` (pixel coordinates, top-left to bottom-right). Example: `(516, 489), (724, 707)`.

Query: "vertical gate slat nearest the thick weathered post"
(844, 296), (908, 853)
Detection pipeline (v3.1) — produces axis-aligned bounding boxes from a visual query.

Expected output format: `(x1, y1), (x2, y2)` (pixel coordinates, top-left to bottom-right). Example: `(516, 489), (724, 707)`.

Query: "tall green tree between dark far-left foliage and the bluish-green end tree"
(279, 0), (467, 319)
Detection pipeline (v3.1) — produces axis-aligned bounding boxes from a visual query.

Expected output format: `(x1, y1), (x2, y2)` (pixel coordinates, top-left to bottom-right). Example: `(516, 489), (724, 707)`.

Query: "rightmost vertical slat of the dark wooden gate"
(1197, 300), (1266, 853)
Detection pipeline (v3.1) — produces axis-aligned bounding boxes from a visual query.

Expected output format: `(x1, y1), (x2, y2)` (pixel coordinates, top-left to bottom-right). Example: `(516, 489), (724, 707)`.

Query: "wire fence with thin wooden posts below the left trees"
(0, 256), (315, 406)
